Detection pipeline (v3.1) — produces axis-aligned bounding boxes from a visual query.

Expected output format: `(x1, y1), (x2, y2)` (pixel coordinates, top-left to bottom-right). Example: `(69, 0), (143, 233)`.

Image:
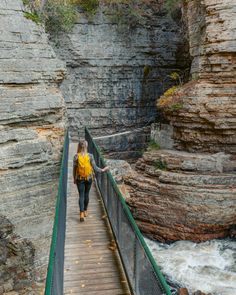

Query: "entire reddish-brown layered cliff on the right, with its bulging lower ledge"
(123, 0), (236, 241)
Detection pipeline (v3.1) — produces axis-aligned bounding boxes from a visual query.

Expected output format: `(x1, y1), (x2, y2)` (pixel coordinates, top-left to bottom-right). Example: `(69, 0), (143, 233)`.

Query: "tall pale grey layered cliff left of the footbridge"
(0, 0), (65, 291)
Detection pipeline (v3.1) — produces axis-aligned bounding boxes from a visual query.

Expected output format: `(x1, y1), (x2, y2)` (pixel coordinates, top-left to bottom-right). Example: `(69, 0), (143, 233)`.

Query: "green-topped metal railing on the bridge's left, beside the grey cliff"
(44, 132), (69, 295)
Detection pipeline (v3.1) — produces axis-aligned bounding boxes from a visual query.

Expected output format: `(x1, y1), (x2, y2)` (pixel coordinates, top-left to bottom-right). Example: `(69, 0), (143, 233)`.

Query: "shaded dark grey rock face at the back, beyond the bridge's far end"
(56, 5), (188, 158)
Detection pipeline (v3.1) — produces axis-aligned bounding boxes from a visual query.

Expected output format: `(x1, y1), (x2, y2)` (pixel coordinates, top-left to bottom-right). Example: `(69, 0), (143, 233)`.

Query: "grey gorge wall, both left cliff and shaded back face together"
(0, 0), (190, 294)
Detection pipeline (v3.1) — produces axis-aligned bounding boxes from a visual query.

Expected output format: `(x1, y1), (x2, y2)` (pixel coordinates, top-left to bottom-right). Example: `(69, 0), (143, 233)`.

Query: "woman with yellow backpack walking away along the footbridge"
(73, 139), (109, 221)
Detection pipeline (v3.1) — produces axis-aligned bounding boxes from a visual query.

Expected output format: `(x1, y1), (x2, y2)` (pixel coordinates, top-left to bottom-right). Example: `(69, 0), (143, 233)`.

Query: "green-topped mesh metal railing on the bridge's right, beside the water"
(85, 128), (171, 295)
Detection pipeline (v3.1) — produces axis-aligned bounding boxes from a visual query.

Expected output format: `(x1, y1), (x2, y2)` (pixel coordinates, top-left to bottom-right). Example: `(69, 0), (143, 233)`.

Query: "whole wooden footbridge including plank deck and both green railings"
(45, 129), (171, 295)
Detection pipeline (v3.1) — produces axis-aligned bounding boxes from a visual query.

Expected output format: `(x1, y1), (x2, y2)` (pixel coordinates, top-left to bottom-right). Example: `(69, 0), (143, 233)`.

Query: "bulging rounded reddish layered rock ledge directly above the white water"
(125, 150), (236, 242)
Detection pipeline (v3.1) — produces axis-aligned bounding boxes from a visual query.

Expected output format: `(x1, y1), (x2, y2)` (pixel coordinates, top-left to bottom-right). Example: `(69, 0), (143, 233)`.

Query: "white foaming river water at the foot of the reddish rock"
(145, 239), (236, 295)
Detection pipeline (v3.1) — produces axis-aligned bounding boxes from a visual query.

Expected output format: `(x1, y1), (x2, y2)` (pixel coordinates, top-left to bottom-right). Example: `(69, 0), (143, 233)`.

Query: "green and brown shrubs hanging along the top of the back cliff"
(23, 0), (181, 34)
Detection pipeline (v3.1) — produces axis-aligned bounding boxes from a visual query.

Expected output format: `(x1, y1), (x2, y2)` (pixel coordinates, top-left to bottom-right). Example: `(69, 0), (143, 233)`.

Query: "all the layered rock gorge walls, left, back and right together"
(0, 0), (236, 294)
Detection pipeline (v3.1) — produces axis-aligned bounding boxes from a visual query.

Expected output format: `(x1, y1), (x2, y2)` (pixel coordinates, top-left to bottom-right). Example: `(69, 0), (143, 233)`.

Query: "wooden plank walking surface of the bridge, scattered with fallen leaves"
(64, 144), (130, 295)
